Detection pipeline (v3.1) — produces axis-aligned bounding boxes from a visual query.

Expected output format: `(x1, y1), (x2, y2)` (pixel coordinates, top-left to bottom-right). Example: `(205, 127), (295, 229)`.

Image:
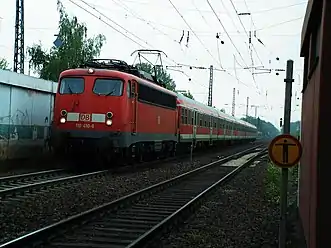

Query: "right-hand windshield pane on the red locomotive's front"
(93, 78), (123, 96)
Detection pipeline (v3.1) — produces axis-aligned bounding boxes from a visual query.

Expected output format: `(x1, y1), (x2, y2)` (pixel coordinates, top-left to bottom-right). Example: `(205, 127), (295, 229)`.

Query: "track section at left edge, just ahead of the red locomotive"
(0, 169), (108, 201)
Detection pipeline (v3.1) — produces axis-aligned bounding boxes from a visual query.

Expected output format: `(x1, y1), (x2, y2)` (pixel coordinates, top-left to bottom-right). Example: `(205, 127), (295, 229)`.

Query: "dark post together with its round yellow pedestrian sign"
(269, 60), (302, 248)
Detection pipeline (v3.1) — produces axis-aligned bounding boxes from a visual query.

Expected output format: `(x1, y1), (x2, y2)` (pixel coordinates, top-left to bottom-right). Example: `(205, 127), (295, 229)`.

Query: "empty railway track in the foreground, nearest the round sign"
(0, 145), (266, 247)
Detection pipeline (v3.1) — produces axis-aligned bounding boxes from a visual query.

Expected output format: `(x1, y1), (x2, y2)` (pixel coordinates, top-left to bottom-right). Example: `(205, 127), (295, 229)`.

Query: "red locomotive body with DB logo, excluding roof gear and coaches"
(52, 66), (178, 160)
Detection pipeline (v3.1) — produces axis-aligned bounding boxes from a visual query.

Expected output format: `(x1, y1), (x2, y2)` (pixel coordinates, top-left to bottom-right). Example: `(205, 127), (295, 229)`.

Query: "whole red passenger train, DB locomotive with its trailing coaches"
(50, 59), (258, 164)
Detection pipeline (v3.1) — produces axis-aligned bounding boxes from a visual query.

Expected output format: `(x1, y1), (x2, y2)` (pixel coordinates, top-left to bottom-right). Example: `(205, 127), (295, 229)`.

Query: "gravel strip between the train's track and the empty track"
(0, 142), (260, 243)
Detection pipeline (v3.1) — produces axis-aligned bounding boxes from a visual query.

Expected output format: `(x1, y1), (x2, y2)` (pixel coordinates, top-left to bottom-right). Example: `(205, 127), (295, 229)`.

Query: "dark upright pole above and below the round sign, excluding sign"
(279, 60), (294, 248)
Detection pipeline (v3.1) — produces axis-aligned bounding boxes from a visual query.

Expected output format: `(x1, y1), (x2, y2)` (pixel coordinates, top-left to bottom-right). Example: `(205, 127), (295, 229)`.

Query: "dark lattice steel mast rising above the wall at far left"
(14, 0), (24, 74)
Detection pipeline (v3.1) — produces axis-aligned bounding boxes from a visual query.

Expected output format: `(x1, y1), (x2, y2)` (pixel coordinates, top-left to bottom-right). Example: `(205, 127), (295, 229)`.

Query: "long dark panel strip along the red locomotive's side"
(138, 84), (177, 109)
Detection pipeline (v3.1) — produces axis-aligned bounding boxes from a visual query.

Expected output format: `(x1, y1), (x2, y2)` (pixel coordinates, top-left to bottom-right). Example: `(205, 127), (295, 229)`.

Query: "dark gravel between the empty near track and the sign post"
(159, 155), (279, 248)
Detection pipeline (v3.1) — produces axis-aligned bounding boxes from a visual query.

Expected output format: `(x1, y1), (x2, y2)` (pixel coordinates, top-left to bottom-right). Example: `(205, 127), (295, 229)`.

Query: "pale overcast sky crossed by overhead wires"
(0, 0), (307, 127)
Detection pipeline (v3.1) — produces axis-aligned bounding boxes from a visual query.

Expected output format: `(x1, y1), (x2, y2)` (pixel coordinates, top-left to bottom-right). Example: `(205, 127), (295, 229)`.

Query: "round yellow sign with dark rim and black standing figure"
(268, 134), (302, 168)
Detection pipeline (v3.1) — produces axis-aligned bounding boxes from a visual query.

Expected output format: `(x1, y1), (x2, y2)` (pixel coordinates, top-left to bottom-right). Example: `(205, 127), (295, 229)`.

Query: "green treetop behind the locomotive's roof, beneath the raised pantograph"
(136, 63), (176, 91)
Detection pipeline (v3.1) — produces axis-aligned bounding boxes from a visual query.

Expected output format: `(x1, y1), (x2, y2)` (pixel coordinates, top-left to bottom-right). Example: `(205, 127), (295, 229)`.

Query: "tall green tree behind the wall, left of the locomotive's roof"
(28, 0), (106, 81)
